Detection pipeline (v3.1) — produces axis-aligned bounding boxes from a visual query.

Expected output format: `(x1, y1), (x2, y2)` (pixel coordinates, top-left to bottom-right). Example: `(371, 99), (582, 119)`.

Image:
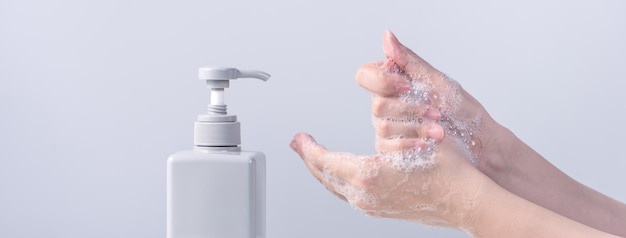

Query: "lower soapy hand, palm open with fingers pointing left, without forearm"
(291, 133), (482, 228)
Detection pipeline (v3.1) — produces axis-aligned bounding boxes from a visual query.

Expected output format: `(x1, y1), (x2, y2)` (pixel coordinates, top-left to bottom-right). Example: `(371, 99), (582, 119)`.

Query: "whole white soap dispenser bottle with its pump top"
(167, 67), (270, 238)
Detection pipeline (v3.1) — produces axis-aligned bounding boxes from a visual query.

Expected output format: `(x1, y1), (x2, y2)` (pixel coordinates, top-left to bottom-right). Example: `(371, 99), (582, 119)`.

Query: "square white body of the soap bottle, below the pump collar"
(167, 147), (265, 238)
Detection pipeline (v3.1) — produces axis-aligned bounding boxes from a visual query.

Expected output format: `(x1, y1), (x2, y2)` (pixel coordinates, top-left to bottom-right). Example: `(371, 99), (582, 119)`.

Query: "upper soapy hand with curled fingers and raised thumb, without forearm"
(356, 31), (494, 166)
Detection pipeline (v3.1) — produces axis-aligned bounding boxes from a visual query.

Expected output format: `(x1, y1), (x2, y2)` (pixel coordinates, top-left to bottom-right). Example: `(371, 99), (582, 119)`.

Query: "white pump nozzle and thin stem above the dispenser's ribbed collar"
(198, 67), (270, 115)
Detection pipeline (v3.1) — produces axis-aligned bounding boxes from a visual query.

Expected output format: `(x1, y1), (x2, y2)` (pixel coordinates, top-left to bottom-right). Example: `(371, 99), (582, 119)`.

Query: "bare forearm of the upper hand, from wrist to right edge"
(485, 126), (626, 236)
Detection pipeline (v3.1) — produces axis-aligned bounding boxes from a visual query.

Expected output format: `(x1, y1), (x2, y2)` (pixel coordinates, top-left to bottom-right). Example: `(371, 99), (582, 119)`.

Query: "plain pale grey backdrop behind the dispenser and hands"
(0, 0), (626, 238)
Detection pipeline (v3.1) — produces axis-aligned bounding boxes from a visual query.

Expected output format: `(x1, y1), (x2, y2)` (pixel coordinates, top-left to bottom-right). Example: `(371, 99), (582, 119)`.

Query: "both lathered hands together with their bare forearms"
(291, 32), (626, 237)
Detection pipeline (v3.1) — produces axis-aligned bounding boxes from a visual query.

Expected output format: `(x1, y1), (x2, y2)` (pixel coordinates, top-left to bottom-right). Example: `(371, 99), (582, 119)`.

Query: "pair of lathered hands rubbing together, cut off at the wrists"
(291, 32), (492, 228)
